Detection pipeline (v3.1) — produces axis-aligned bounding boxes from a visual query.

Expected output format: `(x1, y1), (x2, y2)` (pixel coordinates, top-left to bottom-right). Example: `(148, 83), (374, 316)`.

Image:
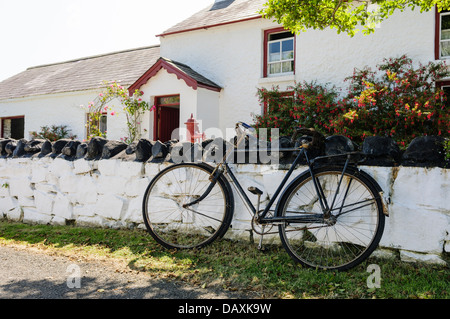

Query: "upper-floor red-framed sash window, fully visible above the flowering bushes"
(264, 28), (295, 77)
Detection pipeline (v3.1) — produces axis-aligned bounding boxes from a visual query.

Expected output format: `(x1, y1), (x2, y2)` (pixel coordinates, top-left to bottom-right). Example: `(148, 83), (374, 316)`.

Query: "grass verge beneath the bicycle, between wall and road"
(0, 220), (450, 299)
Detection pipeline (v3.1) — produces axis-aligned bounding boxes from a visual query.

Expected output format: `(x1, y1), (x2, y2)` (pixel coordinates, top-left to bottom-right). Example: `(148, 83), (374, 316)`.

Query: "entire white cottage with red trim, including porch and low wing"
(0, 0), (450, 140)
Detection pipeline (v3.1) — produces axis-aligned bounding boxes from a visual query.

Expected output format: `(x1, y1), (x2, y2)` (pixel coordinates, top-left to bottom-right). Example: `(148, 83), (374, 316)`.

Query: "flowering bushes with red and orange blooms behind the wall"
(254, 56), (450, 146)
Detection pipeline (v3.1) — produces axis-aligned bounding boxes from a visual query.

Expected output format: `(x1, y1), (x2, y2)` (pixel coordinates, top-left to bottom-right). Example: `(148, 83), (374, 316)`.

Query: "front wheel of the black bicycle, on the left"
(143, 163), (234, 249)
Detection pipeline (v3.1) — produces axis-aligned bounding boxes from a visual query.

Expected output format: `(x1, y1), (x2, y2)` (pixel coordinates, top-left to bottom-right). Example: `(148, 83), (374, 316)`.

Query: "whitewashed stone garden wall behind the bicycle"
(0, 157), (450, 263)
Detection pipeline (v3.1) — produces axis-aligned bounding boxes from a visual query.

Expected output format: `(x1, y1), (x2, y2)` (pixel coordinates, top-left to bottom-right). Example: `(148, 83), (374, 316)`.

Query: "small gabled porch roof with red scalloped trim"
(129, 58), (222, 94)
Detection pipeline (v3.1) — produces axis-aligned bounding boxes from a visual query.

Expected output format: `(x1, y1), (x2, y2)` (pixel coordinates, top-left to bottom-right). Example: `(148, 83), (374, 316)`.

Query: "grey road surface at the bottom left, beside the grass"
(0, 246), (253, 299)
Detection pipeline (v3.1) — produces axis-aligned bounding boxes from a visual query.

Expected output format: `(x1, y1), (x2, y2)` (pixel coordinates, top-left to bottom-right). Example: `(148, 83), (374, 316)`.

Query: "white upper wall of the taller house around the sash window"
(160, 10), (435, 134)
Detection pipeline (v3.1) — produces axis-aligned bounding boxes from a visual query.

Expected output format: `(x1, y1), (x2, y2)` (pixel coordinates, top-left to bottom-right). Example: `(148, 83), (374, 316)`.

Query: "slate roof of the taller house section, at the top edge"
(158, 0), (267, 36)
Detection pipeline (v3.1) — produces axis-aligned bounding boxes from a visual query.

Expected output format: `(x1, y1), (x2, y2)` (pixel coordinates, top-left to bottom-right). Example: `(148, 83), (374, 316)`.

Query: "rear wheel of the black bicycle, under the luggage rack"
(278, 167), (385, 270)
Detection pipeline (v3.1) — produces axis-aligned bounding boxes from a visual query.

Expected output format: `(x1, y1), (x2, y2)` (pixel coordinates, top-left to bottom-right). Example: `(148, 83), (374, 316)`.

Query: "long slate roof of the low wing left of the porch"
(0, 45), (160, 100)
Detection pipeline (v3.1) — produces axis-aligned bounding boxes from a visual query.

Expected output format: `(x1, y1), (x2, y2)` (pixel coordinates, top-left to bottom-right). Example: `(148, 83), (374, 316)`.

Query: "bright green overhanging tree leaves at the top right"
(260, 0), (450, 37)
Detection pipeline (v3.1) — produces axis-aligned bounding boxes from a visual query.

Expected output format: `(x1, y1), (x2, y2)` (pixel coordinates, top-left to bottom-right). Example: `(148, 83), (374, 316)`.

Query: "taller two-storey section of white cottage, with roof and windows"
(154, 0), (450, 138)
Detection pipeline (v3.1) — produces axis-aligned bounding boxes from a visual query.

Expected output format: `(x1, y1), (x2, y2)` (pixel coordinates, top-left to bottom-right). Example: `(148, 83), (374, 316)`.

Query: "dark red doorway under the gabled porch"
(153, 95), (180, 143)
